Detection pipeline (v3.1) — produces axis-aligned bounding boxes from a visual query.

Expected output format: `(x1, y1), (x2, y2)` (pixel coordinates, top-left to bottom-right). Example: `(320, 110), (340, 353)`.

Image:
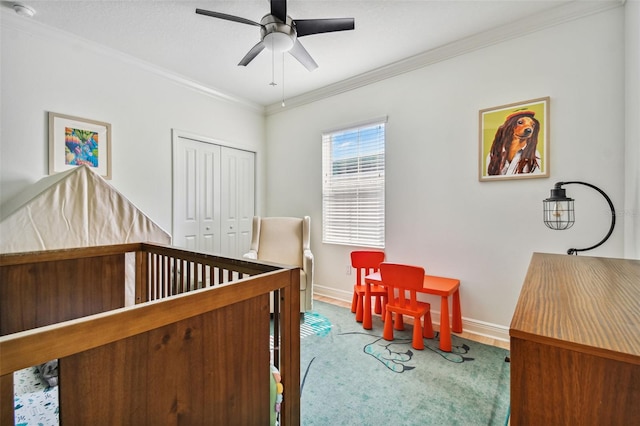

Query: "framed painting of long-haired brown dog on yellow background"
(479, 97), (549, 181)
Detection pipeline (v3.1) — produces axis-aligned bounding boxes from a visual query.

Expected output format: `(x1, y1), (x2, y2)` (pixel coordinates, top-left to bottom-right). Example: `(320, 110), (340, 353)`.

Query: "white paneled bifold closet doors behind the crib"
(173, 135), (255, 257)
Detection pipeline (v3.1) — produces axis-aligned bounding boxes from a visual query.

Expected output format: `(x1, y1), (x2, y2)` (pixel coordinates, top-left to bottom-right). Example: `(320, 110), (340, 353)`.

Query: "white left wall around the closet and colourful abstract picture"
(0, 12), (265, 232)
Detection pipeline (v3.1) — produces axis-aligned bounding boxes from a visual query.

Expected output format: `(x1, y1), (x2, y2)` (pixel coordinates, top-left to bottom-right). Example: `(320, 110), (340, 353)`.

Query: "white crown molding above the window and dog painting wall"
(265, 0), (625, 116)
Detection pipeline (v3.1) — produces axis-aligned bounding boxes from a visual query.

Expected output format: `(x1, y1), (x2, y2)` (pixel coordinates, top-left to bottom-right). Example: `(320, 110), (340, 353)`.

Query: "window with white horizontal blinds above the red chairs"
(322, 118), (386, 248)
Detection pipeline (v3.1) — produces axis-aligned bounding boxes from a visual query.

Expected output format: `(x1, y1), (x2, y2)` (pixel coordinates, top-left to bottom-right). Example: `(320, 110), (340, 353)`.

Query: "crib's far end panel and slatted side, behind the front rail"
(0, 243), (280, 335)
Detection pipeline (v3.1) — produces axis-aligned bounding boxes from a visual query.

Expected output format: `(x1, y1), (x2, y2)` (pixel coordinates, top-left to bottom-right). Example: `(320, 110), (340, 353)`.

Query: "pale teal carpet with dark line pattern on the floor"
(300, 301), (509, 426)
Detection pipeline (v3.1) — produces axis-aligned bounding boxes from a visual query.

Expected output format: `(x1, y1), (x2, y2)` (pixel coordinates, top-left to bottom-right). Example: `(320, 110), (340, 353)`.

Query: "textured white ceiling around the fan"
(2, 0), (616, 106)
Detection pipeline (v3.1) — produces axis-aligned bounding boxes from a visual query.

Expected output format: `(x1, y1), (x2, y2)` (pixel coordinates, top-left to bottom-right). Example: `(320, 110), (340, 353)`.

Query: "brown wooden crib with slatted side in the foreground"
(0, 243), (300, 426)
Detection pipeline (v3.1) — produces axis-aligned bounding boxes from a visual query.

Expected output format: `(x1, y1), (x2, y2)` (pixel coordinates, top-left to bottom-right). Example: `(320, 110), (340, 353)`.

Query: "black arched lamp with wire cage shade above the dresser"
(542, 181), (616, 255)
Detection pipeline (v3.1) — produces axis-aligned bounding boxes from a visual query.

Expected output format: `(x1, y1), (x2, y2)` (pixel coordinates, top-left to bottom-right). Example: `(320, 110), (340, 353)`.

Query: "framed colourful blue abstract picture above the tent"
(49, 112), (111, 179)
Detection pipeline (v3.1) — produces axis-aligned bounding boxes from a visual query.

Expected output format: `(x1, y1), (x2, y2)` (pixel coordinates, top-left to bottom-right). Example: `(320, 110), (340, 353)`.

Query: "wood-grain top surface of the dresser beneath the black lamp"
(509, 253), (640, 364)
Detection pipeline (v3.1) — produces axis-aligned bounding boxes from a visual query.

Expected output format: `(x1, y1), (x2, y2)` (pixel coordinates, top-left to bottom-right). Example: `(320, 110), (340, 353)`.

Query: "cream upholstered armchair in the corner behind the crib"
(243, 216), (313, 312)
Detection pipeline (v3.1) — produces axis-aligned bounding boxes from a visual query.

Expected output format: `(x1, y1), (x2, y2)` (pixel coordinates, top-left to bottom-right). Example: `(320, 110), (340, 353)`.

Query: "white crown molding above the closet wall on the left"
(0, 7), (264, 113)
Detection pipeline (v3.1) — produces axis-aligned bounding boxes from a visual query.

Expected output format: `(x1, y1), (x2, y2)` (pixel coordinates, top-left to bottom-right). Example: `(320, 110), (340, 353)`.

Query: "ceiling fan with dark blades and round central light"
(196, 0), (355, 71)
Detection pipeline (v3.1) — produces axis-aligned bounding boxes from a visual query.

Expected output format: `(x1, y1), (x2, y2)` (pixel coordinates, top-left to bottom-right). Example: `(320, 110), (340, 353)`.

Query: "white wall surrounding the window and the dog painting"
(266, 8), (627, 335)
